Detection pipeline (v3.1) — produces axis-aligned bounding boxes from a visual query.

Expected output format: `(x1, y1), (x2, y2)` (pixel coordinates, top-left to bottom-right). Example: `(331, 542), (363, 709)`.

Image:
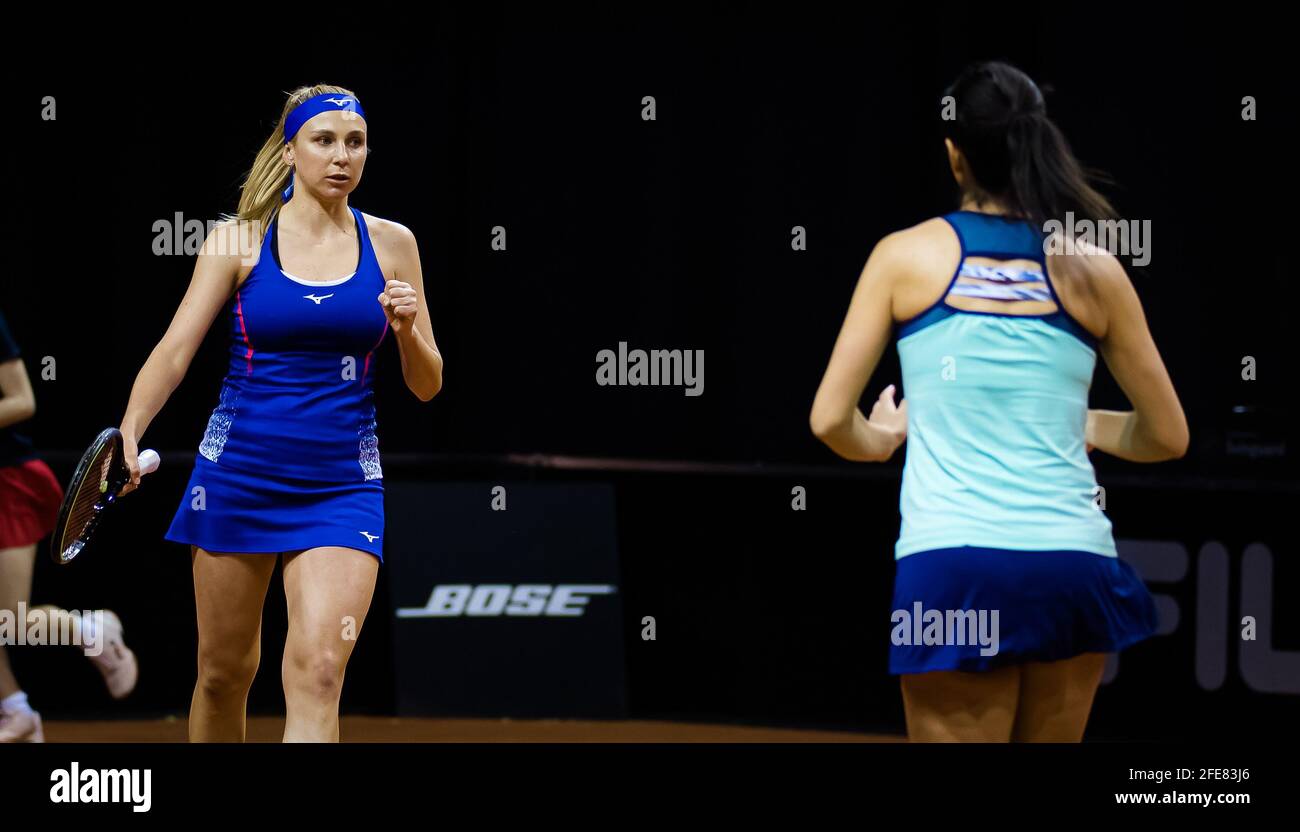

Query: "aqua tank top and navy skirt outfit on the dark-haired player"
(889, 211), (1157, 673)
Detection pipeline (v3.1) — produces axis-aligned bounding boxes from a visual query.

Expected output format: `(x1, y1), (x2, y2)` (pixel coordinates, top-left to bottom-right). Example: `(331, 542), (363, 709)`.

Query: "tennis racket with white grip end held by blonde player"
(49, 428), (161, 564)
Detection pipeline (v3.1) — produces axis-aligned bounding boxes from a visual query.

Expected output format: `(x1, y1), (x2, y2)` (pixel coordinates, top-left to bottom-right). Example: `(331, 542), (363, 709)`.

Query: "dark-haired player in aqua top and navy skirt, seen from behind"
(810, 62), (1188, 741)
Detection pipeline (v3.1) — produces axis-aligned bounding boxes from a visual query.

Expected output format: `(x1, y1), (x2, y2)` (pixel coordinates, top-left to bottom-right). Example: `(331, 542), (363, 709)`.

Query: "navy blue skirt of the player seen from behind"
(889, 546), (1157, 675)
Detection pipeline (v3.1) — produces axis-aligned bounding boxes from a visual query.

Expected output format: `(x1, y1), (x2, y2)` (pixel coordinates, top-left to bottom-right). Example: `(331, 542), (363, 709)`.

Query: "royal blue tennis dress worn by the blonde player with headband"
(165, 208), (389, 562)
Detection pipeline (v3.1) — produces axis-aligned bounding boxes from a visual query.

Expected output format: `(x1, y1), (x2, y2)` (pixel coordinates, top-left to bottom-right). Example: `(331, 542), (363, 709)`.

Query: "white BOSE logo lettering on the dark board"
(398, 584), (615, 619)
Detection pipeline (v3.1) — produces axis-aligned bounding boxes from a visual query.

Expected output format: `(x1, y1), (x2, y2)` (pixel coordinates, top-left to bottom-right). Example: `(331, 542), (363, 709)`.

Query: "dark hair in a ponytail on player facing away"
(943, 61), (1115, 228)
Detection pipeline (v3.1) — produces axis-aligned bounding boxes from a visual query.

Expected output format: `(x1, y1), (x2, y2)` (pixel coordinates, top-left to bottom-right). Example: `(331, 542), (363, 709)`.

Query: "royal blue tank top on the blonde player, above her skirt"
(189, 208), (389, 482)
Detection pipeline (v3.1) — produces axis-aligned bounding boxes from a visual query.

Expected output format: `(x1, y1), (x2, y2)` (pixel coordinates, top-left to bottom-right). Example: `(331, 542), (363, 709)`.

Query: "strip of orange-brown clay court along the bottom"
(35, 716), (905, 742)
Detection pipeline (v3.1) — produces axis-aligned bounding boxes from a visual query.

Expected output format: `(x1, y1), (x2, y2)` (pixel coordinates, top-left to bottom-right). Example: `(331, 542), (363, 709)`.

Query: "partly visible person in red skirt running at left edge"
(0, 304), (138, 742)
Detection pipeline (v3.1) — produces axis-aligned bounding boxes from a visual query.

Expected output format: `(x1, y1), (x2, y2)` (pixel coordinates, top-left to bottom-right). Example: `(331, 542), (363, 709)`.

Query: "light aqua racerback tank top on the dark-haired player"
(894, 211), (1115, 558)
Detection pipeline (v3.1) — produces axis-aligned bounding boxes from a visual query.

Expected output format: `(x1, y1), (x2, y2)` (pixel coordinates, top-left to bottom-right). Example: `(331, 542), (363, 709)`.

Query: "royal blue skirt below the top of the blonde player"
(164, 455), (384, 562)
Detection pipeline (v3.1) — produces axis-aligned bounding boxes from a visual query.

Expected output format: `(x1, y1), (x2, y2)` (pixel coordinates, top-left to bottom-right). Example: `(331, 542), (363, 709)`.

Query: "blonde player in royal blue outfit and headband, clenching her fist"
(121, 85), (442, 741)
